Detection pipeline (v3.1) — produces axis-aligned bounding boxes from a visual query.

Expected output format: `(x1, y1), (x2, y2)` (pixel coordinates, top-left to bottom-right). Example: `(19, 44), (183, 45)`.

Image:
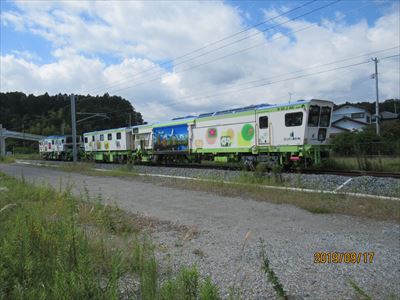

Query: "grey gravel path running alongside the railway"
(0, 164), (400, 299)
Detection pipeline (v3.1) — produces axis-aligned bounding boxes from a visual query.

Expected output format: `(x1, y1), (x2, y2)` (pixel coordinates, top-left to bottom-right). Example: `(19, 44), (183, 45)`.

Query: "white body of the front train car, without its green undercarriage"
(191, 100), (333, 153)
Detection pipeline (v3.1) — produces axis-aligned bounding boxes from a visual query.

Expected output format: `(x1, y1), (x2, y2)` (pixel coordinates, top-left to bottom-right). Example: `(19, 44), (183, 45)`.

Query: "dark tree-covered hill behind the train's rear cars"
(0, 92), (143, 135)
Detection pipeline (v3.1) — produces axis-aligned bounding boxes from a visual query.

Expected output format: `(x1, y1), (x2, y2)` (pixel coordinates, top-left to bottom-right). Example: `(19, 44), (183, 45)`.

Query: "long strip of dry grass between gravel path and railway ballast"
(15, 163), (400, 223)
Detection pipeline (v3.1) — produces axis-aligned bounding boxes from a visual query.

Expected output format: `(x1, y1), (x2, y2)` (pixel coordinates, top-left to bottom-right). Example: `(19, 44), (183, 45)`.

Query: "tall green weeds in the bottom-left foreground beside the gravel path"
(0, 173), (220, 299)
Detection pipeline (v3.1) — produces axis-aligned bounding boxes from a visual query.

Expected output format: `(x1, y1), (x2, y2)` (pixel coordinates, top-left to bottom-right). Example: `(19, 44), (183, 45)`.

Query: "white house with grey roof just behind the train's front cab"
(330, 103), (372, 135)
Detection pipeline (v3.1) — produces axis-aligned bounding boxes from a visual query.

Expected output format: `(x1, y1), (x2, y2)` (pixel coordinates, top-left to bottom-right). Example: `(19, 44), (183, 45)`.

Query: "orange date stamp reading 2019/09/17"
(314, 252), (375, 264)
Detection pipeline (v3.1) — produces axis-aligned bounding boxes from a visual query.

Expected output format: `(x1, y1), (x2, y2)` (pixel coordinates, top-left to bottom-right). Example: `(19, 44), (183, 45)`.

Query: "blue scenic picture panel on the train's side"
(153, 124), (188, 151)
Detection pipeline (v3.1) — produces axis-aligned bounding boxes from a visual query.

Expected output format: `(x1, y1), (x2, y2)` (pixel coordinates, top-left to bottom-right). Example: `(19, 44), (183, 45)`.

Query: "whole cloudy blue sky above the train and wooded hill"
(0, 0), (400, 119)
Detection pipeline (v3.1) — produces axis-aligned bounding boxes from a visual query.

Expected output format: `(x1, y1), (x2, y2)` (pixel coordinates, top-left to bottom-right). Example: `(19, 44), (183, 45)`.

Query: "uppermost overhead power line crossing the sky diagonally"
(84, 0), (318, 92)
